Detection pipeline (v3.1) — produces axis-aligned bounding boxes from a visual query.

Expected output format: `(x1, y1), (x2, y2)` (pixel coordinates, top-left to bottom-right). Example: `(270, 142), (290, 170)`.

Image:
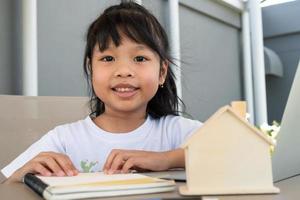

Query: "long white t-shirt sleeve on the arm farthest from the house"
(1, 128), (65, 178)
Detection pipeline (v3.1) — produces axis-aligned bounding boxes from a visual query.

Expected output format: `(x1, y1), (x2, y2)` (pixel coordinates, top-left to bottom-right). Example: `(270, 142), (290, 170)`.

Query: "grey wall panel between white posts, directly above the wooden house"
(180, 3), (242, 121)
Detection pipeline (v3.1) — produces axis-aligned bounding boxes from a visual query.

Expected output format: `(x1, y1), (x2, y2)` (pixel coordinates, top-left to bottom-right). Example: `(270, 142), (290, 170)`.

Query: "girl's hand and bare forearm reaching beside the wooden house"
(103, 149), (184, 174)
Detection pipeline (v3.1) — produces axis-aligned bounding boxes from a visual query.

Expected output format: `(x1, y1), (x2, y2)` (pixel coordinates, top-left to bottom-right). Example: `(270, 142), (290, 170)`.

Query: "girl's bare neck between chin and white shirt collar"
(94, 112), (146, 133)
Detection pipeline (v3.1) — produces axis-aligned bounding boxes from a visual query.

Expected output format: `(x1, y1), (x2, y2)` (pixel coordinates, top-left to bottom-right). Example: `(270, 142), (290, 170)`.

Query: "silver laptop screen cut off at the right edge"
(272, 58), (300, 181)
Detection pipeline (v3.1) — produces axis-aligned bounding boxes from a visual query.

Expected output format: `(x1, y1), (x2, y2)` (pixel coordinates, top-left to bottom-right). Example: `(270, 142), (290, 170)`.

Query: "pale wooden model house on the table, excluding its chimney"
(179, 106), (279, 195)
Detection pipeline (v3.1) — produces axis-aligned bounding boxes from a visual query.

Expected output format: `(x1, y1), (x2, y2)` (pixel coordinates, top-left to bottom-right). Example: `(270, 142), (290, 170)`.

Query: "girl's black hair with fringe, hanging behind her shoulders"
(84, 1), (184, 118)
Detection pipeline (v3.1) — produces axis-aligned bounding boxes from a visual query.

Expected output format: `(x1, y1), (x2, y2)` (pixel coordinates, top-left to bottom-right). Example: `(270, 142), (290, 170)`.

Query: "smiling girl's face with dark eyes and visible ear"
(92, 35), (167, 115)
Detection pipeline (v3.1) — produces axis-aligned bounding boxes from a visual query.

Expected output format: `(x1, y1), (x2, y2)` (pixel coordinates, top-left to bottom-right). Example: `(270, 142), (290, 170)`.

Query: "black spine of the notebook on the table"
(24, 173), (48, 197)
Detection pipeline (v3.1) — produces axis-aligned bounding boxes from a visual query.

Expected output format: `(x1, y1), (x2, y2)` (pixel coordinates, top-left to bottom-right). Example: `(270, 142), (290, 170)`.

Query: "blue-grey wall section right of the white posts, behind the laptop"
(262, 0), (300, 123)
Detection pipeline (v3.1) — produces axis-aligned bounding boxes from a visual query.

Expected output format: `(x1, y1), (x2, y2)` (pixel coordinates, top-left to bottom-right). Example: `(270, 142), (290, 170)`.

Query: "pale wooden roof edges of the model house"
(181, 106), (275, 148)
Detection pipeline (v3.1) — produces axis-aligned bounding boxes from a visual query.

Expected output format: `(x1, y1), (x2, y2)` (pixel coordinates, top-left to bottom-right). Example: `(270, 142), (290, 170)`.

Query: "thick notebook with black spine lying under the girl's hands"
(24, 172), (175, 199)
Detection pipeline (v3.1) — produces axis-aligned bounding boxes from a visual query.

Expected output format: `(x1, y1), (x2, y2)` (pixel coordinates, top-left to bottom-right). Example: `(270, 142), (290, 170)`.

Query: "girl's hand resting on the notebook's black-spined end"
(5, 152), (78, 183)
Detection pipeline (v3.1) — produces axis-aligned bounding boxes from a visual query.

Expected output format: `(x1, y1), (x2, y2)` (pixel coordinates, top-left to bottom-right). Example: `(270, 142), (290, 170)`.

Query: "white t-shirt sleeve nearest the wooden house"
(168, 116), (203, 149)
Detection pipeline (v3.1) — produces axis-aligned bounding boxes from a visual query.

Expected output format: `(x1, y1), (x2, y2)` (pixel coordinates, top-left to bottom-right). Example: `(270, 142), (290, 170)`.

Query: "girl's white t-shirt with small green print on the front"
(1, 115), (202, 177)
